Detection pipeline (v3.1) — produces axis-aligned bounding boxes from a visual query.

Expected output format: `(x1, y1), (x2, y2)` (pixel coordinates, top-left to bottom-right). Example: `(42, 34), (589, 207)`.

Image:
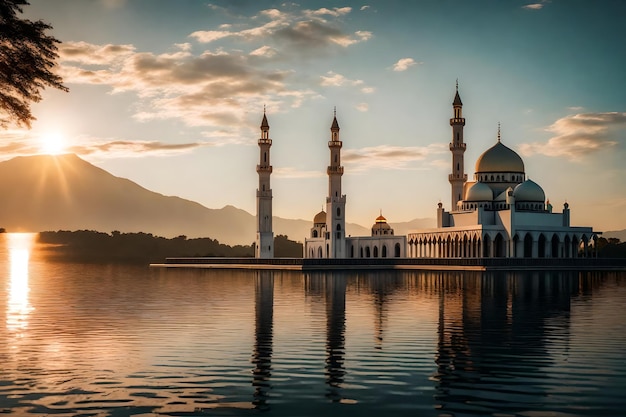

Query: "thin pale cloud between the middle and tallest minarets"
(342, 144), (445, 172)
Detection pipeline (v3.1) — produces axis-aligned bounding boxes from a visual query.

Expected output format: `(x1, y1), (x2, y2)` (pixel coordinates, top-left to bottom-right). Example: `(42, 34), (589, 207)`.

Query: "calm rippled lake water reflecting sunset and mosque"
(0, 234), (626, 417)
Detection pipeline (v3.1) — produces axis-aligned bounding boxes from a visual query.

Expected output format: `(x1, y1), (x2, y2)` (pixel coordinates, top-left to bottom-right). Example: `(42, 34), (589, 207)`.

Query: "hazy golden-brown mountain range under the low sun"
(0, 154), (434, 245)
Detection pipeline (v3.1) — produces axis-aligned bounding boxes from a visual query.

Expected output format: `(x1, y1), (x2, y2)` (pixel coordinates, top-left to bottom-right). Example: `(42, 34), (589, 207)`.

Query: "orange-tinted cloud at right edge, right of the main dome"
(520, 112), (626, 159)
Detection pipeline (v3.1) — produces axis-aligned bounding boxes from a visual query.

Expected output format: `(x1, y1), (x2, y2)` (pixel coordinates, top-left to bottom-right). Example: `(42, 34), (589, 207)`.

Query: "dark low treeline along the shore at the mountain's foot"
(38, 230), (302, 263)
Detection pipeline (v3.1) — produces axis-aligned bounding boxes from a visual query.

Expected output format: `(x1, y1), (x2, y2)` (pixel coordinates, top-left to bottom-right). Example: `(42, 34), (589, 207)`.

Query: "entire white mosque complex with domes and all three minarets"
(256, 84), (596, 258)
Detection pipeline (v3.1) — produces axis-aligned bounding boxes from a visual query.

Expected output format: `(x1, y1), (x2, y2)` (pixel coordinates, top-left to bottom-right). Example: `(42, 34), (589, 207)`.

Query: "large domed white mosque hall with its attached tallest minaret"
(407, 84), (596, 258)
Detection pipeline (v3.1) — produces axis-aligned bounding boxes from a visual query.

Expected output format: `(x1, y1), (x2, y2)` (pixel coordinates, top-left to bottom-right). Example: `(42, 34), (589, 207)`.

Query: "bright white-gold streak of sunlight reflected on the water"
(6, 233), (35, 333)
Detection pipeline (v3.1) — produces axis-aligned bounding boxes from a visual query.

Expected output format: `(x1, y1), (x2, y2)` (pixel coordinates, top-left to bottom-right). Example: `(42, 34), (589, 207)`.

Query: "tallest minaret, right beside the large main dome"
(448, 80), (467, 211)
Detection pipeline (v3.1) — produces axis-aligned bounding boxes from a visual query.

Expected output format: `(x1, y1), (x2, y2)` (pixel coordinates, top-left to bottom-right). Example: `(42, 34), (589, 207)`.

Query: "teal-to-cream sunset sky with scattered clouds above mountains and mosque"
(0, 0), (626, 231)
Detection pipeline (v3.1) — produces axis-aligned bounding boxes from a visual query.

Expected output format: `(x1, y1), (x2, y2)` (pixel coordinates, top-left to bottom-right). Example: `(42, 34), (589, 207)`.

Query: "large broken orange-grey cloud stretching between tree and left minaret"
(60, 43), (316, 126)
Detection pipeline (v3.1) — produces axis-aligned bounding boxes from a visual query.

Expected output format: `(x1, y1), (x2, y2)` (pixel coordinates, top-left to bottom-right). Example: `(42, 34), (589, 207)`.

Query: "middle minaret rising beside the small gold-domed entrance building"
(326, 110), (346, 258)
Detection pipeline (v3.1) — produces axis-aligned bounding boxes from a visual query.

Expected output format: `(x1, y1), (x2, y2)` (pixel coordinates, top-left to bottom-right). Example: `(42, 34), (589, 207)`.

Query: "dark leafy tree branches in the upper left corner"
(0, 0), (68, 128)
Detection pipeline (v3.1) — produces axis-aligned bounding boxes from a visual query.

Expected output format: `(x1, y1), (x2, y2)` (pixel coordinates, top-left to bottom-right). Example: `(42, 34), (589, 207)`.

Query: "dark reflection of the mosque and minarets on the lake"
(247, 271), (606, 413)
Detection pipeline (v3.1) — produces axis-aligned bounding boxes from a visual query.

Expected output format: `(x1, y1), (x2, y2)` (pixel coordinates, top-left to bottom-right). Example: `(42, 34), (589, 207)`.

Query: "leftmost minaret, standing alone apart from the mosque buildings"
(255, 109), (274, 258)
